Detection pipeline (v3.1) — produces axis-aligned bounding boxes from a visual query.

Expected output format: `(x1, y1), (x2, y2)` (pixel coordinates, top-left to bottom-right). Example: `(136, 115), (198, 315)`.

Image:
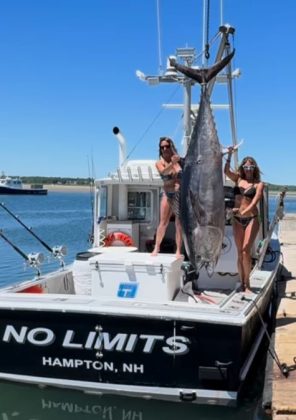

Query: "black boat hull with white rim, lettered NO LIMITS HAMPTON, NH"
(0, 244), (277, 405)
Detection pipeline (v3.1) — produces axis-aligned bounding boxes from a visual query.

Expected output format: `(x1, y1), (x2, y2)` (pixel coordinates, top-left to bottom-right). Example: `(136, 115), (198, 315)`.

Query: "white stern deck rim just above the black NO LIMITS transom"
(0, 264), (271, 325)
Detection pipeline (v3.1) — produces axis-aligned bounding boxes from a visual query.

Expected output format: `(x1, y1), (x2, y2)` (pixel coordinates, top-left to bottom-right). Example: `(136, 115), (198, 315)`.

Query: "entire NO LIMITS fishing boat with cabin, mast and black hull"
(0, 6), (283, 405)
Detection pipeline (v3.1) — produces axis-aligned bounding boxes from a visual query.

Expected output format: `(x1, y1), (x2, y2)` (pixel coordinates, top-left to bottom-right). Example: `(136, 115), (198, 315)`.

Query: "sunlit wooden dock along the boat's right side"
(262, 214), (296, 420)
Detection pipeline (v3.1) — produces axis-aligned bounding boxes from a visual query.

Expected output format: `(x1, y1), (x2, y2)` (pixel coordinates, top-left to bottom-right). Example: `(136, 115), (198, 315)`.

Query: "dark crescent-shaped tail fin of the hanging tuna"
(171, 50), (235, 84)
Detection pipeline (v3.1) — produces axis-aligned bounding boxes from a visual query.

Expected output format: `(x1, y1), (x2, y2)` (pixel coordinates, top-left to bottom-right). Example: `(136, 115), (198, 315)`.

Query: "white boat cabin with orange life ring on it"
(94, 160), (162, 252)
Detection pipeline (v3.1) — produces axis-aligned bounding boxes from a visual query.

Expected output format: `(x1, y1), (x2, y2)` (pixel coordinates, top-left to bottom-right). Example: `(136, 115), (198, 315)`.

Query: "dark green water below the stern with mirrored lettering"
(0, 382), (268, 420)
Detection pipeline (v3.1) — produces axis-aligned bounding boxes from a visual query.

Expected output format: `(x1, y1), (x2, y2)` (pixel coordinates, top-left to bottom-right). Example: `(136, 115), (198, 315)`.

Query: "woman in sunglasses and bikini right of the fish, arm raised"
(224, 147), (264, 292)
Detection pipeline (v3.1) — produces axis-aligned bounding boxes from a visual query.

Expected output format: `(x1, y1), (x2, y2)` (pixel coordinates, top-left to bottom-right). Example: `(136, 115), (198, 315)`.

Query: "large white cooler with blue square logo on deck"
(89, 252), (182, 302)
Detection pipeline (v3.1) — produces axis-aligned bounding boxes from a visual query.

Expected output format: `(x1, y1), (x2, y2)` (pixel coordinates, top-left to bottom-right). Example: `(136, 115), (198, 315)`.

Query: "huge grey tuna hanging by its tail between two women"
(171, 51), (234, 276)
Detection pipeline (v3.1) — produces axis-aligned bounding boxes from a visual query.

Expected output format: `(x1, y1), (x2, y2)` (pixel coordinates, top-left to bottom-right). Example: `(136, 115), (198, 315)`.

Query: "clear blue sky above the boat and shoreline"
(0, 0), (296, 184)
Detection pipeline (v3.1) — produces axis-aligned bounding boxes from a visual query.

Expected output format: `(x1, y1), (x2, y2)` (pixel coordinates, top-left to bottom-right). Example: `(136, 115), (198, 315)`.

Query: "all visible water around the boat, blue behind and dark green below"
(0, 192), (296, 420)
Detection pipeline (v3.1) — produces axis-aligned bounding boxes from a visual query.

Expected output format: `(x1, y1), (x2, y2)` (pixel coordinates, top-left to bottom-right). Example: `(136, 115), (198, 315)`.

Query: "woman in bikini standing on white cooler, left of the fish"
(151, 137), (182, 258)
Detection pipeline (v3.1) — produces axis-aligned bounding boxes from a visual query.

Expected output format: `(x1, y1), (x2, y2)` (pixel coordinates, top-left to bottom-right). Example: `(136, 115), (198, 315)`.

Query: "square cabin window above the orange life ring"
(127, 191), (151, 221)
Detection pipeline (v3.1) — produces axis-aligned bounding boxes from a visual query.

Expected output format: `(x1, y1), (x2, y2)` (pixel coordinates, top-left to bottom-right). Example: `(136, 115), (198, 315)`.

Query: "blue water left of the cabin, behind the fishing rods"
(0, 192), (92, 286)
